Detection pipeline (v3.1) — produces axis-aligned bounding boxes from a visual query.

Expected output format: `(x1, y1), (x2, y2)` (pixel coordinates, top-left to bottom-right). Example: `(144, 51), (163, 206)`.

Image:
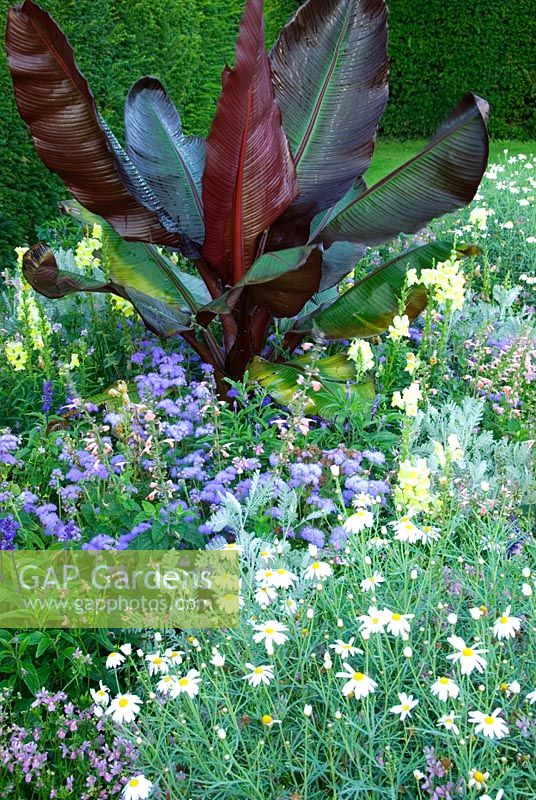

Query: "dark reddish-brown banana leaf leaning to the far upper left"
(6, 0), (182, 247)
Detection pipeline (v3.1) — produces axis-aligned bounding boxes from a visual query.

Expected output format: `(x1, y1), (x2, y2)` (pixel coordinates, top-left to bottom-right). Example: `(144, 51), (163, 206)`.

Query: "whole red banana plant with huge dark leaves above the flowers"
(6, 0), (488, 410)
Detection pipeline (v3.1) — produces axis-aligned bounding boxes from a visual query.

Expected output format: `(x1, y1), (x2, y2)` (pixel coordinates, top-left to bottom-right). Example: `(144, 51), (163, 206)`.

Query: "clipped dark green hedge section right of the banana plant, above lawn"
(382, 0), (536, 140)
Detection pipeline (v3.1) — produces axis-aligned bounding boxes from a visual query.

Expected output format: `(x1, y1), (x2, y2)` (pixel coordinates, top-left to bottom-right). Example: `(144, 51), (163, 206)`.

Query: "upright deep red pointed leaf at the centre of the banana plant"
(203, 0), (297, 284)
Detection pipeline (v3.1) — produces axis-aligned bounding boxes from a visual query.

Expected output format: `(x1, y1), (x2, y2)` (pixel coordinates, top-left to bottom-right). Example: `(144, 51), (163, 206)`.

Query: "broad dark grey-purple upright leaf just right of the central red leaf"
(270, 0), (388, 246)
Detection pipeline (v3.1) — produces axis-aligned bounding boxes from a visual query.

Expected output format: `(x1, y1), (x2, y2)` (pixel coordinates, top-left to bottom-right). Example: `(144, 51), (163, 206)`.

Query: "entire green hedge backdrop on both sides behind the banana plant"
(0, 0), (536, 262)
